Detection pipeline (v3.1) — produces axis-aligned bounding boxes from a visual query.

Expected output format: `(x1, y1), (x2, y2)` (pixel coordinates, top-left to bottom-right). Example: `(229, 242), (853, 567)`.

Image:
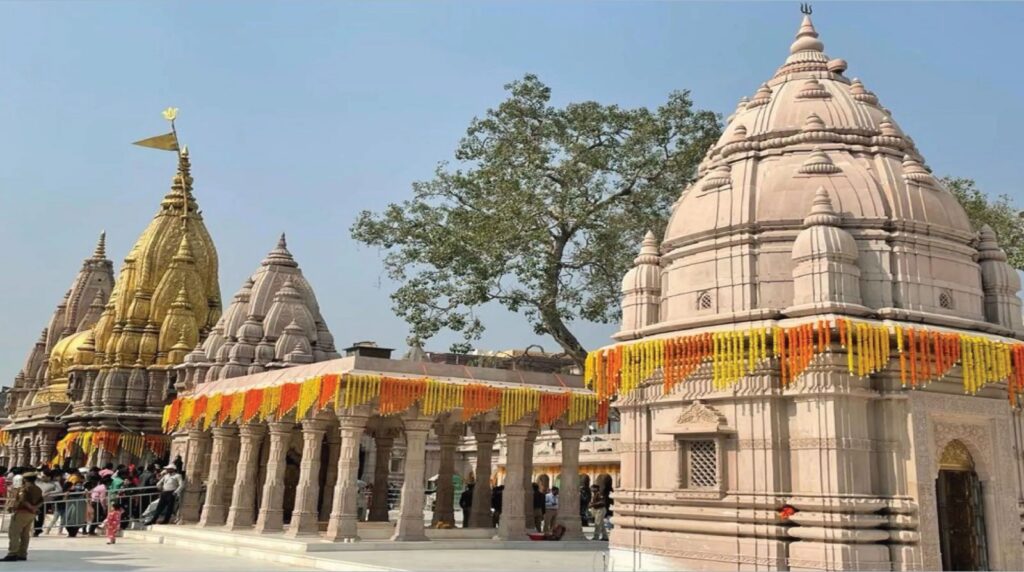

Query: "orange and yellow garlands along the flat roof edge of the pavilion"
(162, 373), (608, 432)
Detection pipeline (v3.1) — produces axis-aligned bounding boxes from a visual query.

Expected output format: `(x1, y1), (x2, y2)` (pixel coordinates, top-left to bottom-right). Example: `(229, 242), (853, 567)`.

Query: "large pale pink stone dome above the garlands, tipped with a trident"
(616, 12), (1024, 340)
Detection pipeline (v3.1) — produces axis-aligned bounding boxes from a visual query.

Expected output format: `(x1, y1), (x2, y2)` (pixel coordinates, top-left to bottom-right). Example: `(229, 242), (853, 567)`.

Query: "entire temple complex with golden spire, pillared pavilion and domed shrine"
(0, 6), (1024, 571)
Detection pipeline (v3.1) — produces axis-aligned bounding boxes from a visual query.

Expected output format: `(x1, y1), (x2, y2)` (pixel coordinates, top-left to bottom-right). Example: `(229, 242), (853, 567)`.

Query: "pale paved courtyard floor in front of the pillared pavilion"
(14, 535), (607, 572)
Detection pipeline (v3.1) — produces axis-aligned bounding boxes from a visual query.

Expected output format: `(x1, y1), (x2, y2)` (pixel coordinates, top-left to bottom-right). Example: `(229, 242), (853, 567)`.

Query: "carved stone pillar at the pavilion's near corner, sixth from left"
(326, 412), (368, 542)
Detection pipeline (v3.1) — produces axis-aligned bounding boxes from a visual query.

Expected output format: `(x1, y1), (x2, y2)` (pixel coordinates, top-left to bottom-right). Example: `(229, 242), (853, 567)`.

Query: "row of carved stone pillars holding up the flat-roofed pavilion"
(181, 411), (584, 541)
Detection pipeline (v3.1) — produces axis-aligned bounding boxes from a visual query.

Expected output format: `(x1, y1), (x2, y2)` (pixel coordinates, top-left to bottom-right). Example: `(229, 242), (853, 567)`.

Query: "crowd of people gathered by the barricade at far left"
(0, 457), (184, 562)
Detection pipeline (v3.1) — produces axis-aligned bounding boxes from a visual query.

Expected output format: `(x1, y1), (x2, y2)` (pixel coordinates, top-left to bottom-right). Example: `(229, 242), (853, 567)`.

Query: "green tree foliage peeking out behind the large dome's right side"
(942, 177), (1024, 270)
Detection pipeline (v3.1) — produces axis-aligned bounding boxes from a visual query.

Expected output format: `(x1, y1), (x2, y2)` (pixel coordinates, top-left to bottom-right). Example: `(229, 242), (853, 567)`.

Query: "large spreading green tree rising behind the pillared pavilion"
(351, 75), (721, 363)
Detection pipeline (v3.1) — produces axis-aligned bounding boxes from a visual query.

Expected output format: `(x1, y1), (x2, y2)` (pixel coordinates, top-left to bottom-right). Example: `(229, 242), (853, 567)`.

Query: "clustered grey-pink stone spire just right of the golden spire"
(177, 234), (341, 388)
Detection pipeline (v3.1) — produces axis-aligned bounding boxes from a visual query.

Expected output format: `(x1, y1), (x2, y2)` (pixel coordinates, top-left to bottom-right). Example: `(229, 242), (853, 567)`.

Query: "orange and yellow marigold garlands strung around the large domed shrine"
(584, 318), (1024, 405)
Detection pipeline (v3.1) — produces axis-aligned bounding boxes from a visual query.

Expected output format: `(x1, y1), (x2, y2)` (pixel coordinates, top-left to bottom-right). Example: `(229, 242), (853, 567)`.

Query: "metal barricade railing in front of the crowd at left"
(16, 486), (160, 535)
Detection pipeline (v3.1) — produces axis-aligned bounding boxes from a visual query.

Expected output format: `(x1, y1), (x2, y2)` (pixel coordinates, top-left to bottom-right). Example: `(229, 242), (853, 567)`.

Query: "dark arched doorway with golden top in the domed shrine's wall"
(935, 439), (988, 570)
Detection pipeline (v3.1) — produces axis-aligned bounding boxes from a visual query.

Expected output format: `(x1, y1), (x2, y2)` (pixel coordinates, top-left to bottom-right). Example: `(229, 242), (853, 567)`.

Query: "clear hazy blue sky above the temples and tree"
(0, 0), (1024, 383)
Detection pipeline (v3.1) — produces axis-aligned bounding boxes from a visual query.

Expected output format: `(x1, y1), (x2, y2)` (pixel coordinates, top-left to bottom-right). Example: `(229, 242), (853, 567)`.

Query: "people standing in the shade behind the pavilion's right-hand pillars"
(459, 482), (612, 540)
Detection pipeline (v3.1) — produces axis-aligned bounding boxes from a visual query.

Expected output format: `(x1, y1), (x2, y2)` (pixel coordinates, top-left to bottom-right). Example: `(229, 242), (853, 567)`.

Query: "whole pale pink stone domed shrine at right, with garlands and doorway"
(587, 10), (1024, 570)
